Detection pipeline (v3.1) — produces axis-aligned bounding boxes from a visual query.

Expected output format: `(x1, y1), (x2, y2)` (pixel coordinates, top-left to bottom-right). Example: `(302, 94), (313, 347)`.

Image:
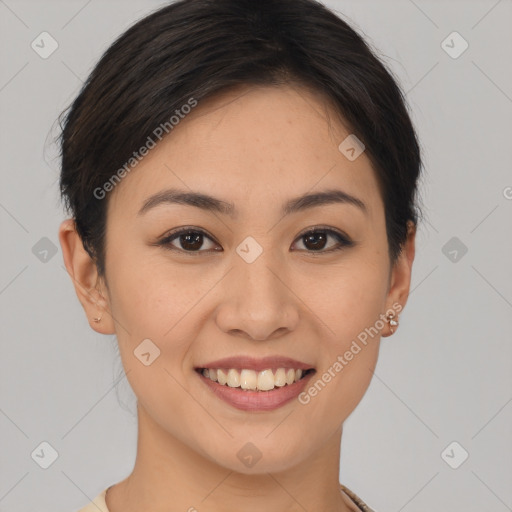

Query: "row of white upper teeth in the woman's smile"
(203, 368), (302, 391)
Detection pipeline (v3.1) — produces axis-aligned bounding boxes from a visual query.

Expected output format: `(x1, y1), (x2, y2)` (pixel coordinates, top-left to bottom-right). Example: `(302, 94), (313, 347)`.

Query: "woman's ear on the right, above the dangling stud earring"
(382, 221), (416, 337)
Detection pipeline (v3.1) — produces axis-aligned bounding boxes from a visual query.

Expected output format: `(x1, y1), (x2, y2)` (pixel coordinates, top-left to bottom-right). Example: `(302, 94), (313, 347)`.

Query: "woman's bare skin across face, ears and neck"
(59, 85), (415, 512)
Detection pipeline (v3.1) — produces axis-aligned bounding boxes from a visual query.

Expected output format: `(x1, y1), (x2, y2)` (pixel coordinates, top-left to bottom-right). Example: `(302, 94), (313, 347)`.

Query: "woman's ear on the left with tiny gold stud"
(59, 219), (115, 334)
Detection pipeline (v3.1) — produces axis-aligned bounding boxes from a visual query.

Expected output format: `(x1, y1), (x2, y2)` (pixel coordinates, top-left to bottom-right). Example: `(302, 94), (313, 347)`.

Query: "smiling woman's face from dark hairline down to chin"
(73, 86), (412, 473)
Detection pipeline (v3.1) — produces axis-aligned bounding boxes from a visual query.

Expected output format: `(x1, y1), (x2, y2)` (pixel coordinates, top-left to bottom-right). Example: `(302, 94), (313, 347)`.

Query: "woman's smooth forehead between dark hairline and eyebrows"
(109, 85), (382, 221)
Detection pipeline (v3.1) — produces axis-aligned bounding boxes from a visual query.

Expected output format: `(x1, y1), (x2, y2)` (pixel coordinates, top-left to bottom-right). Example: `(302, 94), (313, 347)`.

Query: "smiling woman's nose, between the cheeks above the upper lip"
(216, 251), (300, 341)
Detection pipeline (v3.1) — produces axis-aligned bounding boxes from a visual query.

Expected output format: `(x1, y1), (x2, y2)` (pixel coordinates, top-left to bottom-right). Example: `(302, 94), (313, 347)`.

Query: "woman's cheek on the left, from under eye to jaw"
(111, 265), (204, 427)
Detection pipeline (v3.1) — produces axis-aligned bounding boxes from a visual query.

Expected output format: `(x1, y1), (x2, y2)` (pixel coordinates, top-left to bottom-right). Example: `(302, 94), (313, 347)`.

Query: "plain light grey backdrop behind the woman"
(0, 0), (512, 512)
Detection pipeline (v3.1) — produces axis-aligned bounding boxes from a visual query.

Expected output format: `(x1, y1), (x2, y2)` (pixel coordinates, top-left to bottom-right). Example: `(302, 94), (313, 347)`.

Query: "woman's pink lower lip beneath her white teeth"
(196, 370), (315, 411)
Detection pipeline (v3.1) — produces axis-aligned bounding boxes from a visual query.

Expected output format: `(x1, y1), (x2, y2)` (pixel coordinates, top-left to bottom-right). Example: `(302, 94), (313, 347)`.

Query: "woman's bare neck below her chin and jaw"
(106, 405), (357, 512)
